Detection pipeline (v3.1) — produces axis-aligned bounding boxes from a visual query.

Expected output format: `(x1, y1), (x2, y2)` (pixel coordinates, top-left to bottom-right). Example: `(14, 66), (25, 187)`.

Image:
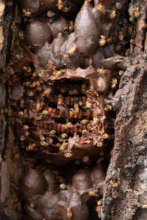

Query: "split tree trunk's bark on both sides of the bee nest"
(0, 0), (147, 220)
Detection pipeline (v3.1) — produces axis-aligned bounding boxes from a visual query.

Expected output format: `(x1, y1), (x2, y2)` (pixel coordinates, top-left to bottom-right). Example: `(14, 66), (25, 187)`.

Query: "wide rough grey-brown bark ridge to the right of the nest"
(101, 1), (147, 217)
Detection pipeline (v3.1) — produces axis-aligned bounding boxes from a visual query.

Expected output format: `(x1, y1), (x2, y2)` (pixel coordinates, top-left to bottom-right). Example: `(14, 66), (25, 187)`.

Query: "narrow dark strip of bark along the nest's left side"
(0, 0), (20, 220)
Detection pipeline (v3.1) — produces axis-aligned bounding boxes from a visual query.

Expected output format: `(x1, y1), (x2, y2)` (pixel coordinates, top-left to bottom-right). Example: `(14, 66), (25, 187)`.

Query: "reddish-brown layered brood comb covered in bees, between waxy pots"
(12, 67), (107, 160)
